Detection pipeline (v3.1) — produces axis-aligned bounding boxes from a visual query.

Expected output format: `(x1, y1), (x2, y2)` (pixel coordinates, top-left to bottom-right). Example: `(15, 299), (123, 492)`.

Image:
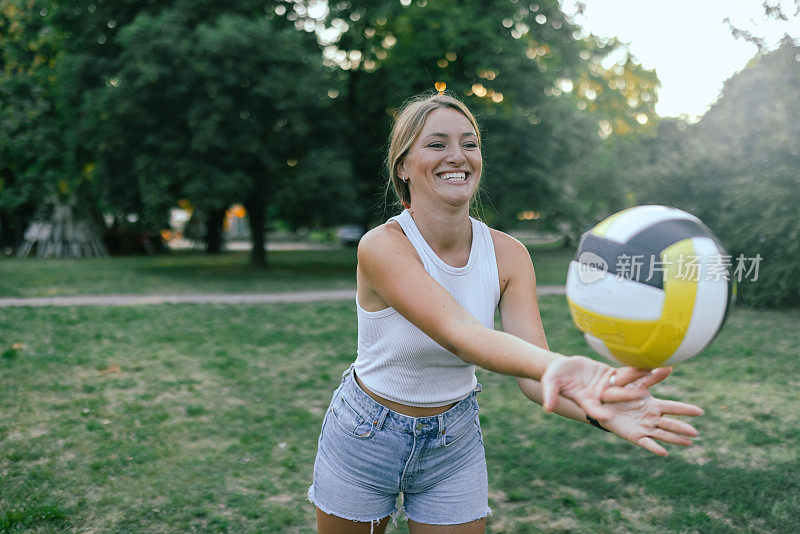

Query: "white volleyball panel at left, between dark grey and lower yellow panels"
(567, 261), (664, 321)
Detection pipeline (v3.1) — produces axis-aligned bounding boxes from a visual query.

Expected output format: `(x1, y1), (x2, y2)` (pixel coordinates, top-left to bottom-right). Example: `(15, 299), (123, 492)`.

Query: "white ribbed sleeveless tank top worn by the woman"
(354, 210), (500, 407)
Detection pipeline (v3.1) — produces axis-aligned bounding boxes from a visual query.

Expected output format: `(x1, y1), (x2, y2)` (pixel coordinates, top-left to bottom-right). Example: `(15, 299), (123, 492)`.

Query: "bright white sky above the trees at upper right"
(562, 0), (800, 118)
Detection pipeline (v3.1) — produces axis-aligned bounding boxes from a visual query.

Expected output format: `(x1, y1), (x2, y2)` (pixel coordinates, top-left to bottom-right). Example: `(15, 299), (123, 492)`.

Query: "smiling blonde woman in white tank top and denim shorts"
(309, 94), (702, 534)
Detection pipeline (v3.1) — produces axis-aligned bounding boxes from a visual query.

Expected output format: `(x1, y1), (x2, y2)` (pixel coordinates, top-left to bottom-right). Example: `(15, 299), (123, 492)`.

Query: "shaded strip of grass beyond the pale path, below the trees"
(0, 247), (572, 297)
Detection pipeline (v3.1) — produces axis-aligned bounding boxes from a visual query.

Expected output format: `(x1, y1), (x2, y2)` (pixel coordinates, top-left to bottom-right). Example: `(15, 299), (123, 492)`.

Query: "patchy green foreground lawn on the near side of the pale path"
(0, 300), (800, 533)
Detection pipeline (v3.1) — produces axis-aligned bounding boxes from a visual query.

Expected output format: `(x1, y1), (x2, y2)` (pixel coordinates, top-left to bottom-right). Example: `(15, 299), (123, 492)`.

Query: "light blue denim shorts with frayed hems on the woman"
(308, 367), (491, 525)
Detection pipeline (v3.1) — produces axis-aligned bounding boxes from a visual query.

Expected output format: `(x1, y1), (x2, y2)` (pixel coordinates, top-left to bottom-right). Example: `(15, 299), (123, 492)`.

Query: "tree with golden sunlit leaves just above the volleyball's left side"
(516, 36), (659, 239)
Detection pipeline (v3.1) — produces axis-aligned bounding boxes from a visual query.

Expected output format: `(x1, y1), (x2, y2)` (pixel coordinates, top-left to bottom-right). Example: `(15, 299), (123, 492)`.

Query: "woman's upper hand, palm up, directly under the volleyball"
(541, 356), (651, 421)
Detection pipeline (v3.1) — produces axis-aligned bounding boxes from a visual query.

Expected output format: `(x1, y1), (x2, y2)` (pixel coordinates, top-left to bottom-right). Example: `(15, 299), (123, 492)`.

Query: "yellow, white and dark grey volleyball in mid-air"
(566, 205), (735, 369)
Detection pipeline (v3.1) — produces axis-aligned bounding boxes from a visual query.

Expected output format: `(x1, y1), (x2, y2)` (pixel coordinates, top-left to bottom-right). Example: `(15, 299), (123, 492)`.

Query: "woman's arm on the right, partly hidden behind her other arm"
(492, 230), (703, 456)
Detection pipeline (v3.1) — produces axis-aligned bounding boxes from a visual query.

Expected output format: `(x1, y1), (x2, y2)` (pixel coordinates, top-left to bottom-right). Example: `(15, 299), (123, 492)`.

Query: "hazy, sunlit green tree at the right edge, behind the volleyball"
(632, 40), (800, 306)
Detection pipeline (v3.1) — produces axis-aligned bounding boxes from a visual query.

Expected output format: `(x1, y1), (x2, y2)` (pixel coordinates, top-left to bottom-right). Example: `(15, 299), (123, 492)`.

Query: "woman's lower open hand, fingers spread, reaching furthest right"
(601, 367), (703, 456)
